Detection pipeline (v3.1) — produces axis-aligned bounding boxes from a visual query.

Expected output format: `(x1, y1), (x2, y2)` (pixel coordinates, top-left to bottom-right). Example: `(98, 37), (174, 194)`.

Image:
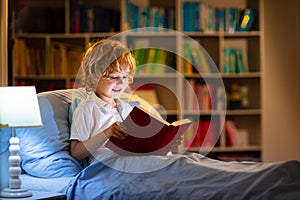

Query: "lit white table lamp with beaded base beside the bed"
(0, 86), (42, 198)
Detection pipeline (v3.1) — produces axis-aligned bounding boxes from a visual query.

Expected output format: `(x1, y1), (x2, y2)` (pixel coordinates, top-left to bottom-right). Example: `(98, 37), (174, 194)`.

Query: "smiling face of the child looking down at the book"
(96, 66), (129, 103)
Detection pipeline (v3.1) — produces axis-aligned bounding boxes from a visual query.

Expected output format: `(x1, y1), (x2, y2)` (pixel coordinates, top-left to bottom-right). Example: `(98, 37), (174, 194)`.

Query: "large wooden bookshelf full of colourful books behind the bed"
(10, 0), (263, 160)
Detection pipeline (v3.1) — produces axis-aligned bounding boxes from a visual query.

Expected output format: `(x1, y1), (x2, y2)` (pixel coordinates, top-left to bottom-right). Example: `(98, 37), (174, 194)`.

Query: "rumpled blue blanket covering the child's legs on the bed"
(67, 154), (300, 200)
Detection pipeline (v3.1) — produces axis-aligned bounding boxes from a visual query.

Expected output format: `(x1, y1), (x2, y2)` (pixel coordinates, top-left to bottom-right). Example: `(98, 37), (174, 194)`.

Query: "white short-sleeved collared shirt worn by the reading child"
(70, 92), (132, 162)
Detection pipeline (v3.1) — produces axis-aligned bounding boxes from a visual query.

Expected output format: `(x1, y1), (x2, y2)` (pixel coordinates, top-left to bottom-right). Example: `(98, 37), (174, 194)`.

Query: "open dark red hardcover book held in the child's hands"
(105, 106), (192, 155)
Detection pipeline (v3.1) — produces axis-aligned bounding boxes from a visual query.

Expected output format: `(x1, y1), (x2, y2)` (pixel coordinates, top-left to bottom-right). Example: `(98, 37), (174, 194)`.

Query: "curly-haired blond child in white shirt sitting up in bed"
(70, 40), (136, 160)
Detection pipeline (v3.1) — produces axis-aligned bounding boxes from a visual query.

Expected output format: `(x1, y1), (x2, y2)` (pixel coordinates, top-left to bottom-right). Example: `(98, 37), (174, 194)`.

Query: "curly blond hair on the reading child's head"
(80, 39), (136, 92)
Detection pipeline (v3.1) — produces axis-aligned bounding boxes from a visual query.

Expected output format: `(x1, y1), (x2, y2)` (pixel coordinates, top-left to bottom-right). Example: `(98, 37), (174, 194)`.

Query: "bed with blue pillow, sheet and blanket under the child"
(0, 89), (300, 200)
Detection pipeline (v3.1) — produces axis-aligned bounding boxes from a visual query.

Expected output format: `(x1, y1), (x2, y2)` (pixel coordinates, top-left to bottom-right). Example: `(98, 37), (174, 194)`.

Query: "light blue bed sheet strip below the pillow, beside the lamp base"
(20, 174), (75, 193)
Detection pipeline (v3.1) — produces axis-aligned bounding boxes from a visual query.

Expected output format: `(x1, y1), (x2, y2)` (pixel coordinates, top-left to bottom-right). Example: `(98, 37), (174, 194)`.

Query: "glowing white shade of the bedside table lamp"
(0, 86), (42, 127)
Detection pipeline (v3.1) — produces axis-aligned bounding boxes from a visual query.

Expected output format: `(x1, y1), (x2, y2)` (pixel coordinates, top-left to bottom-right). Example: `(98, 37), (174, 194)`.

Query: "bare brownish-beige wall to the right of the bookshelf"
(262, 0), (300, 162)
